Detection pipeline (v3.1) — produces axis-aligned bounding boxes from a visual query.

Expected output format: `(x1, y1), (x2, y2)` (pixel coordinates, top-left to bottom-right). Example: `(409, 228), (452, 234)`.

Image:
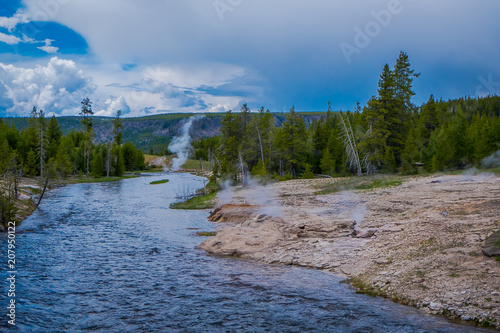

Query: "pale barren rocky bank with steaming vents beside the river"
(200, 175), (500, 329)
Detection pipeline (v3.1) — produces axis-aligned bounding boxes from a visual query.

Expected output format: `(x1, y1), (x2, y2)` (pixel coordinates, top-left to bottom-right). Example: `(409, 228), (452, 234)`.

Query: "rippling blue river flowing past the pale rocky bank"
(0, 174), (488, 333)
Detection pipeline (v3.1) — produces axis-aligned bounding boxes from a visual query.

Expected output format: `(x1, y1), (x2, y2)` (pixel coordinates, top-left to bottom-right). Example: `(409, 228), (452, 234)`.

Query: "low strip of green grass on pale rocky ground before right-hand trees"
(315, 175), (404, 195)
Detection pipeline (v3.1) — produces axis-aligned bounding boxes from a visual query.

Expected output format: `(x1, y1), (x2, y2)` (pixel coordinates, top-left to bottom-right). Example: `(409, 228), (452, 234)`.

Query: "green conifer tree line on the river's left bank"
(0, 98), (145, 222)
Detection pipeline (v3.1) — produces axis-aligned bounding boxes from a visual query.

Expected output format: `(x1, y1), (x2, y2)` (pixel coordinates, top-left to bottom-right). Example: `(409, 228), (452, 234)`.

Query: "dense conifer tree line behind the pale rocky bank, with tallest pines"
(193, 52), (500, 181)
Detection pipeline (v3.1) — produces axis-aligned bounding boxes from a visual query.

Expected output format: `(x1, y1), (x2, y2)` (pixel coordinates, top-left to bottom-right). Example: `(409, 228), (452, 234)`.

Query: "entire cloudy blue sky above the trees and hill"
(0, 0), (500, 117)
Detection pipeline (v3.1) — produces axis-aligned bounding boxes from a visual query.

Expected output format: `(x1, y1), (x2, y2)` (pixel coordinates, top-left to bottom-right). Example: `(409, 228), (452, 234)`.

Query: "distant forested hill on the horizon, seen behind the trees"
(2, 112), (324, 153)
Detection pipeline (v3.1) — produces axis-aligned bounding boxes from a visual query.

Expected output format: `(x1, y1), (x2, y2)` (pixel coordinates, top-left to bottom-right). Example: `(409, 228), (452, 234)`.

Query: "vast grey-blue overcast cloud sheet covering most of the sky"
(0, 0), (500, 115)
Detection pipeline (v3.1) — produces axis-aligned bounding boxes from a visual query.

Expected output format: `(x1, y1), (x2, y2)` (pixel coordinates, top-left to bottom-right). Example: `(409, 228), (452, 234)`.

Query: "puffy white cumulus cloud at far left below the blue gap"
(0, 57), (96, 115)
